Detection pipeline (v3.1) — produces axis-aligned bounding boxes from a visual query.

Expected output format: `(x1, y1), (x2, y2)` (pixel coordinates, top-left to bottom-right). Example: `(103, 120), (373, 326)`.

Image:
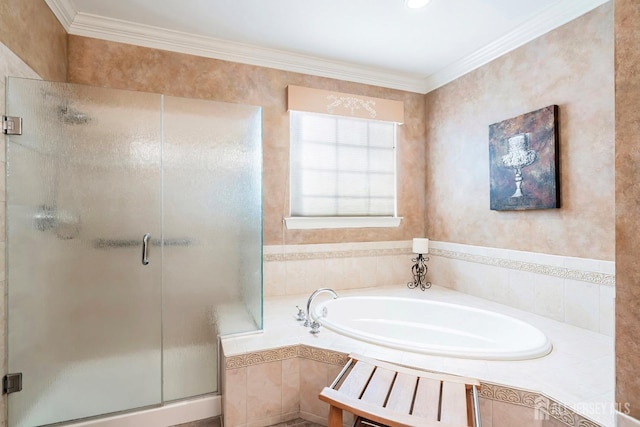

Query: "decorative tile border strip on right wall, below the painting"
(429, 249), (616, 286)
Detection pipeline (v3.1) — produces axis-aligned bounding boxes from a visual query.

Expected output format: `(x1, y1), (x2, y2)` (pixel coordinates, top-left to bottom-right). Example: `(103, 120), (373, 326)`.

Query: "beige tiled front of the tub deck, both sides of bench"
(224, 344), (600, 427)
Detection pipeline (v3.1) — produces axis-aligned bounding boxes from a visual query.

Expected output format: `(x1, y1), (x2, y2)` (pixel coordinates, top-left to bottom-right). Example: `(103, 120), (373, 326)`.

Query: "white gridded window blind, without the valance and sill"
(290, 111), (396, 217)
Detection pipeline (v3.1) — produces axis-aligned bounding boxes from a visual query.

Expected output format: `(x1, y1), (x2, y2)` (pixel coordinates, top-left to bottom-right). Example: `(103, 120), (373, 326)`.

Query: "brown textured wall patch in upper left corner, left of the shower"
(0, 0), (67, 82)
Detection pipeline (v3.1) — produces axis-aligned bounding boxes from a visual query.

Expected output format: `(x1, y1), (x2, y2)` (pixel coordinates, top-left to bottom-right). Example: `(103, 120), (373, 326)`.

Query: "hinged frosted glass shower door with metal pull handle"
(7, 78), (162, 426)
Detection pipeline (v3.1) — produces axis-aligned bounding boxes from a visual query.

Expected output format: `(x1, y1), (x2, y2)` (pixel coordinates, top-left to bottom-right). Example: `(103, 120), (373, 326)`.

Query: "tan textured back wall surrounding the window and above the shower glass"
(69, 36), (425, 245)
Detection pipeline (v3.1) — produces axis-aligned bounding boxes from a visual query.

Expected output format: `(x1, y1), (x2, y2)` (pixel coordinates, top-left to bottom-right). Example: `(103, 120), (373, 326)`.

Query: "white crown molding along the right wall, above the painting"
(423, 0), (609, 93)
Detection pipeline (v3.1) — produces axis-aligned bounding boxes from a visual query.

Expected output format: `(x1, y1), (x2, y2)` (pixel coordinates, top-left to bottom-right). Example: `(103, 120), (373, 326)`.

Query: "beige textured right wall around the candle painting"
(425, 3), (615, 260)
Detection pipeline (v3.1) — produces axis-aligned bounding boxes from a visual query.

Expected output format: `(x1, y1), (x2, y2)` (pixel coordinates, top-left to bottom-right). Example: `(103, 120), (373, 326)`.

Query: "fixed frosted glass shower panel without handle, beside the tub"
(162, 96), (262, 401)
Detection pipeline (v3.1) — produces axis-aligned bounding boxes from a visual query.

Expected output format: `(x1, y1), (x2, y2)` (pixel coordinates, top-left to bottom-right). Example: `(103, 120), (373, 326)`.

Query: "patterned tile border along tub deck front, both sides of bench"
(225, 344), (601, 427)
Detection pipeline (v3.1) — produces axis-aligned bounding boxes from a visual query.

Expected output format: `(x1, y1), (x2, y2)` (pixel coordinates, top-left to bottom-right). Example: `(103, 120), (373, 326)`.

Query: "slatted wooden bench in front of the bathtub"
(319, 354), (480, 427)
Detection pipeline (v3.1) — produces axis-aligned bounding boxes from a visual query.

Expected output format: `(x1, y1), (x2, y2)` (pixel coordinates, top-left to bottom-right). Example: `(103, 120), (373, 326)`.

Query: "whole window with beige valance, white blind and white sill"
(285, 86), (404, 228)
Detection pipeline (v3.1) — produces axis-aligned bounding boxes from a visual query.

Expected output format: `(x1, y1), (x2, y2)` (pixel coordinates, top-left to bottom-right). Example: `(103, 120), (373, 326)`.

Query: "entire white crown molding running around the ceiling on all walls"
(45, 0), (610, 93)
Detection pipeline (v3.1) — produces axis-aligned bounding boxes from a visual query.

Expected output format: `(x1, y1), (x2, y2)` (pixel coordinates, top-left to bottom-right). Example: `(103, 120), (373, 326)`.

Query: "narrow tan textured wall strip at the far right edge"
(615, 0), (640, 419)
